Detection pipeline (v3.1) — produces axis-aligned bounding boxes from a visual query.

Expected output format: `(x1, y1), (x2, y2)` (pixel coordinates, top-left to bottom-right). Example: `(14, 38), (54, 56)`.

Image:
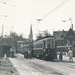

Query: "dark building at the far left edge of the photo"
(0, 36), (14, 57)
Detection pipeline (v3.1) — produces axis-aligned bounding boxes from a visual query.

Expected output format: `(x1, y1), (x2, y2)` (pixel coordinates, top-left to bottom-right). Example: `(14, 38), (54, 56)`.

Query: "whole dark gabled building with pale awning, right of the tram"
(53, 28), (75, 56)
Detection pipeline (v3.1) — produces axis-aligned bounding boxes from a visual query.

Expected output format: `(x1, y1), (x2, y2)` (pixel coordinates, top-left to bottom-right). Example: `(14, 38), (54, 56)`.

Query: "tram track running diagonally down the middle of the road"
(17, 55), (68, 75)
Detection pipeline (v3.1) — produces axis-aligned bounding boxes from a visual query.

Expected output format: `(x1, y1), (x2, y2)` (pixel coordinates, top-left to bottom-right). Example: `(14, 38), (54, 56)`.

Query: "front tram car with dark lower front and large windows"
(32, 36), (57, 60)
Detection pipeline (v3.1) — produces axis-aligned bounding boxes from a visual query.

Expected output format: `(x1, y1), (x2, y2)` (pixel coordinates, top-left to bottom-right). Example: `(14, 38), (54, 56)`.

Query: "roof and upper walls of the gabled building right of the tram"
(53, 28), (75, 46)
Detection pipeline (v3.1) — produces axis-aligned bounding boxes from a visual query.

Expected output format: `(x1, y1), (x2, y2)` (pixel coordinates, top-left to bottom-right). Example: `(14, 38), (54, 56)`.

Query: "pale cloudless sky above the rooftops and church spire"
(0, 0), (75, 39)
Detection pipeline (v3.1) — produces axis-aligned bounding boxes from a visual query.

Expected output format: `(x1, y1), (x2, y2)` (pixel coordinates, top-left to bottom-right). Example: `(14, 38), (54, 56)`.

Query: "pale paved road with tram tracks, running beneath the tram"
(10, 54), (75, 75)
